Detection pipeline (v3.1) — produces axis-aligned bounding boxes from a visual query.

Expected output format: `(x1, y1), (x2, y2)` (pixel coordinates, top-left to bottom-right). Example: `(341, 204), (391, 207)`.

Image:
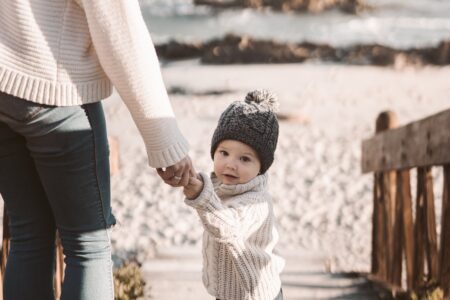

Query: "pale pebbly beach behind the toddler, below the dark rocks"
(104, 61), (450, 272)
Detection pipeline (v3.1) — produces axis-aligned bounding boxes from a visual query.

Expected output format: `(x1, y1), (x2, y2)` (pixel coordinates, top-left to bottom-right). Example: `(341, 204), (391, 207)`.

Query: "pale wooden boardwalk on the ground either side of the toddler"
(142, 248), (380, 300)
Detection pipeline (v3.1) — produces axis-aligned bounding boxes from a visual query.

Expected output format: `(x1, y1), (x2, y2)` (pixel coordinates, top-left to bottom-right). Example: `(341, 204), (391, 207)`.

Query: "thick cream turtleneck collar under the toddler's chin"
(211, 172), (268, 198)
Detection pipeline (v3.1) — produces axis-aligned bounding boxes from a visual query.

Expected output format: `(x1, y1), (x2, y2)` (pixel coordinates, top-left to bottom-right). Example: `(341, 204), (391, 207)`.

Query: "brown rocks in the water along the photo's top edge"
(194, 0), (370, 14)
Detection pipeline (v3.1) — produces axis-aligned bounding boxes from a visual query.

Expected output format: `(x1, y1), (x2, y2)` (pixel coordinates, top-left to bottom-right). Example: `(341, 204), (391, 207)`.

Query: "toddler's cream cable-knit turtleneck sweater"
(185, 173), (284, 300)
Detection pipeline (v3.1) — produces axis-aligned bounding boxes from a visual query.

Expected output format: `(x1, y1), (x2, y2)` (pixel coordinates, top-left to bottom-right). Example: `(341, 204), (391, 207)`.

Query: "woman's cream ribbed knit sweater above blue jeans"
(0, 0), (188, 167)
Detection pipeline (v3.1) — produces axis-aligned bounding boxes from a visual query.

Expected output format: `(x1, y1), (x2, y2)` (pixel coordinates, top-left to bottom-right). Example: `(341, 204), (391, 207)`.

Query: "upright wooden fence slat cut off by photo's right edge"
(439, 165), (450, 299)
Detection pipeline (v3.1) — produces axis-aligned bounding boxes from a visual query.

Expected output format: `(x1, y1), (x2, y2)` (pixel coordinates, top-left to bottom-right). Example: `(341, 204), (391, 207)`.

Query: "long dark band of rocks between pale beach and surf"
(156, 34), (450, 67)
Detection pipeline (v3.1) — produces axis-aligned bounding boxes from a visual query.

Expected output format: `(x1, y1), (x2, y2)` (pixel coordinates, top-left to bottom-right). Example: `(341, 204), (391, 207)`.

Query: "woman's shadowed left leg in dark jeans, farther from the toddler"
(0, 122), (56, 300)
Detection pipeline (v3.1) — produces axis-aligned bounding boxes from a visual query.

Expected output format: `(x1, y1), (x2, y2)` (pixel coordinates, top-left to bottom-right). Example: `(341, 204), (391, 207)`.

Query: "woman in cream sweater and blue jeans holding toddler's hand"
(0, 0), (191, 300)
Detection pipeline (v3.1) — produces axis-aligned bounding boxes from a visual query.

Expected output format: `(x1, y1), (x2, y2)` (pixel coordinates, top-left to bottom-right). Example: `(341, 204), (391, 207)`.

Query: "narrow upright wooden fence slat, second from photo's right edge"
(424, 167), (438, 281)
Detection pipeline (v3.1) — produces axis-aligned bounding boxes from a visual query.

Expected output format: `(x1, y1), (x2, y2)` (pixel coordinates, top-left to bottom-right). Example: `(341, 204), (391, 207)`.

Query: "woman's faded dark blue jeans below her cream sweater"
(0, 92), (115, 300)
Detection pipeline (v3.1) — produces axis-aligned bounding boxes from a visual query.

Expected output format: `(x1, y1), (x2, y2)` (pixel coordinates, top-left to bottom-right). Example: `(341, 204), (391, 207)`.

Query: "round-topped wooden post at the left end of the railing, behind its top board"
(372, 111), (397, 282)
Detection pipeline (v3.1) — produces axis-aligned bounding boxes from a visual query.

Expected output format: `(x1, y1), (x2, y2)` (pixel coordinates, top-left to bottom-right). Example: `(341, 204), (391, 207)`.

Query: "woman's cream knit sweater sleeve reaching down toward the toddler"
(76, 0), (188, 168)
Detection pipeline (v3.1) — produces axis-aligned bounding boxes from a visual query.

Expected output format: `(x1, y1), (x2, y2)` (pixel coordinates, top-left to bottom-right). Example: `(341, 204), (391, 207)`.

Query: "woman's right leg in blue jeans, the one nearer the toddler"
(0, 92), (115, 300)
